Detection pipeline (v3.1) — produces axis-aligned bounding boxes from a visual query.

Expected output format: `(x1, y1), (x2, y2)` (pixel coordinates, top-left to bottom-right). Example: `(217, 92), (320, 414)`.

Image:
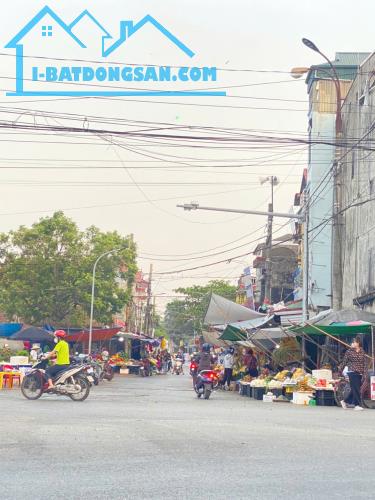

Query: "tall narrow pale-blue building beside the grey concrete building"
(305, 52), (368, 311)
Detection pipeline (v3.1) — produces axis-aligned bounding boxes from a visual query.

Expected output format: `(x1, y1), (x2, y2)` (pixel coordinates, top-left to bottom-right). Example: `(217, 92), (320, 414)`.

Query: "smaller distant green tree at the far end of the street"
(164, 280), (237, 340)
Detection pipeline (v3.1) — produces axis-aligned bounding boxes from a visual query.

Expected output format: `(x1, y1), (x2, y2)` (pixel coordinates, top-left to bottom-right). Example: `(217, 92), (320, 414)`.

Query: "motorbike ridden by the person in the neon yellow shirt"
(21, 358), (90, 401)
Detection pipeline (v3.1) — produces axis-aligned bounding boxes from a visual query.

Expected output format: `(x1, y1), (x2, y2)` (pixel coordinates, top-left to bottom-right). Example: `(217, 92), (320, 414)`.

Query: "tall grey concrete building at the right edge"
(337, 53), (375, 312)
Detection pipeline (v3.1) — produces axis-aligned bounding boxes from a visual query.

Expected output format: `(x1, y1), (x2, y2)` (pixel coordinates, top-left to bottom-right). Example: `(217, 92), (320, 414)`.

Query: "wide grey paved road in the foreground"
(0, 375), (375, 500)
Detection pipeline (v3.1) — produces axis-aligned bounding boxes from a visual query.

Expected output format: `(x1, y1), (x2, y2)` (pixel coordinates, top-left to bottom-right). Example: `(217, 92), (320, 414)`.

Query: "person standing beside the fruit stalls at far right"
(339, 335), (368, 410)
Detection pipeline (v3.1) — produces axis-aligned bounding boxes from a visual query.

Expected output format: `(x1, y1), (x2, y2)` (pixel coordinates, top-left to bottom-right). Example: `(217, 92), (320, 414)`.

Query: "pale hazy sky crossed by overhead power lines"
(0, 0), (375, 311)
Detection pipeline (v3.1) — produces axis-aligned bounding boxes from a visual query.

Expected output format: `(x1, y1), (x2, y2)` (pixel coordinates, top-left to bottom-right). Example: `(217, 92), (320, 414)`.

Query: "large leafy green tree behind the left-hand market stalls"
(0, 212), (137, 326)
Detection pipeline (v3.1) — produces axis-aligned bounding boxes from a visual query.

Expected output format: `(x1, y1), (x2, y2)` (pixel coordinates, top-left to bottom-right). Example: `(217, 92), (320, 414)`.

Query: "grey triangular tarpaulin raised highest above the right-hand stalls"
(204, 293), (265, 325)
